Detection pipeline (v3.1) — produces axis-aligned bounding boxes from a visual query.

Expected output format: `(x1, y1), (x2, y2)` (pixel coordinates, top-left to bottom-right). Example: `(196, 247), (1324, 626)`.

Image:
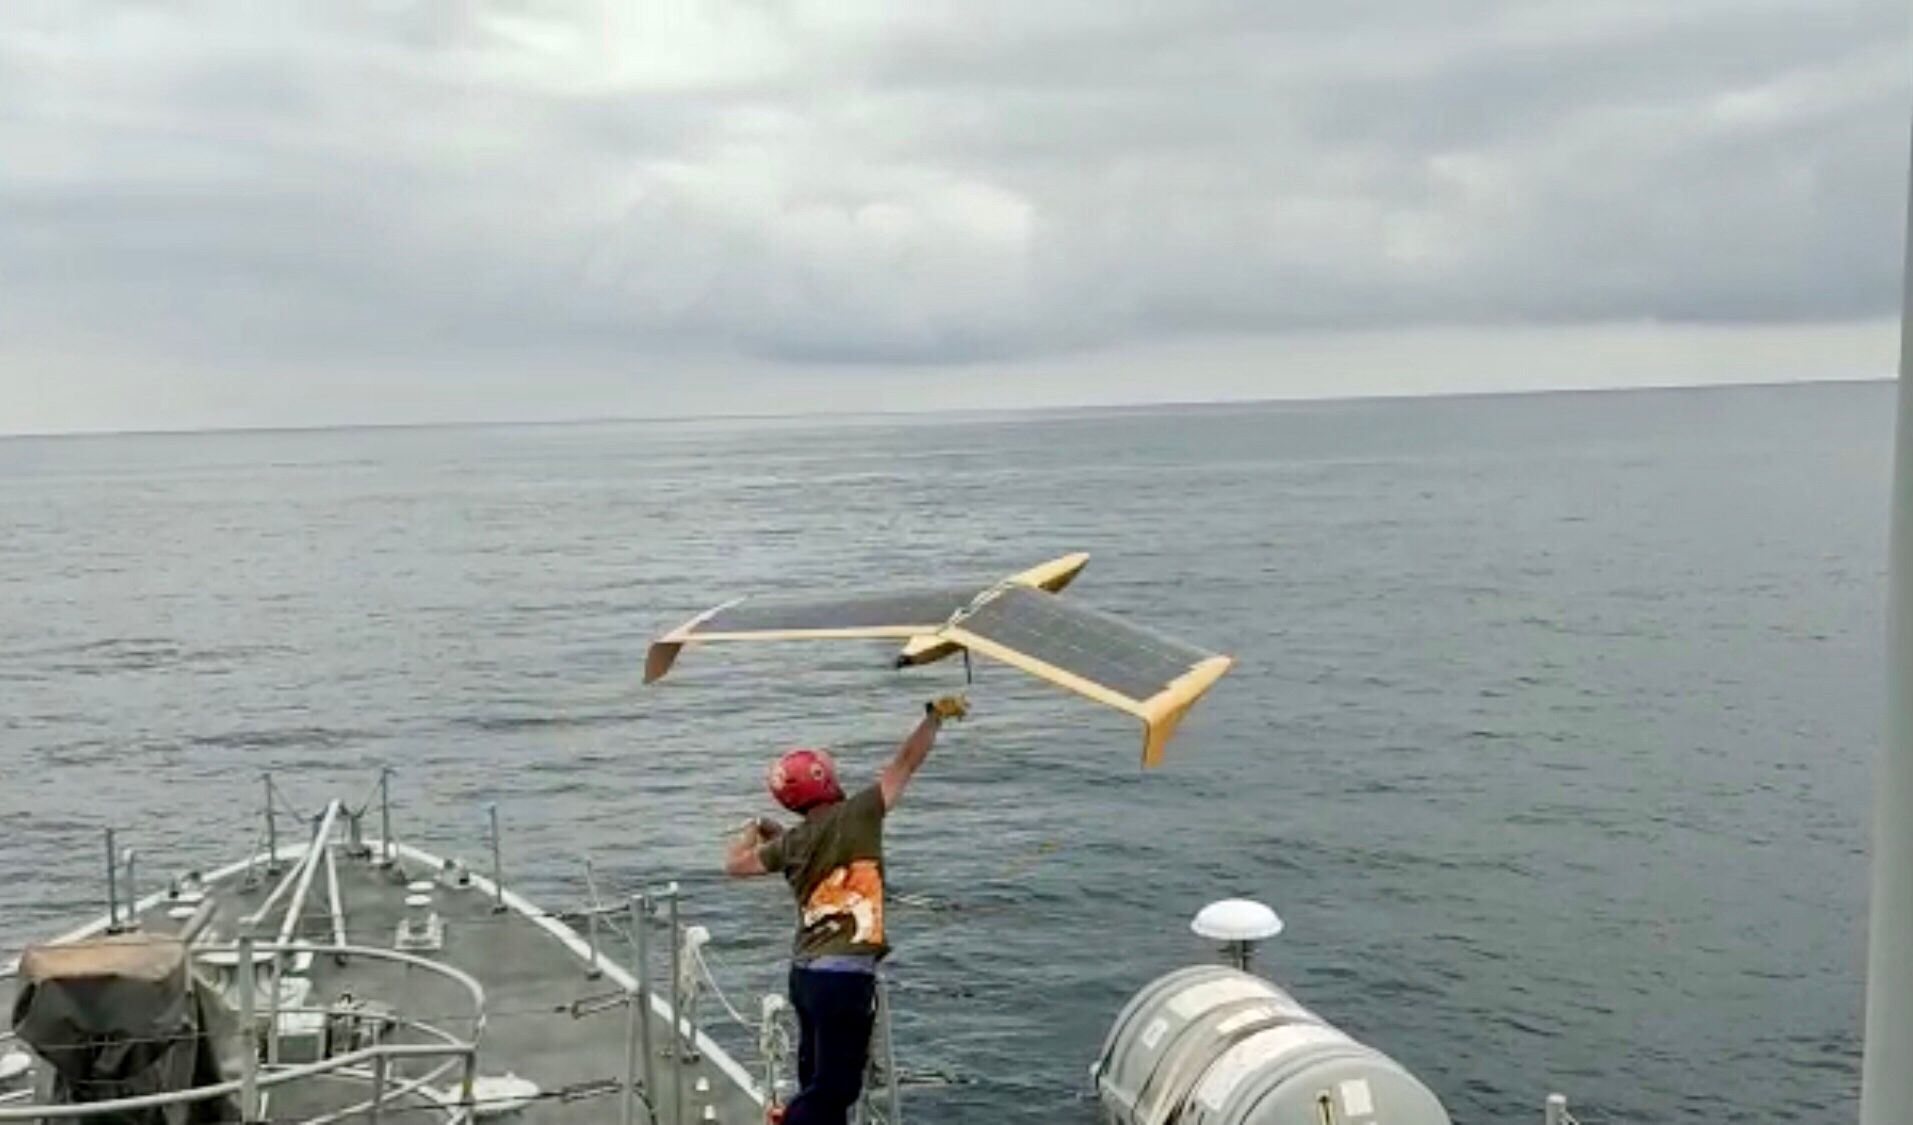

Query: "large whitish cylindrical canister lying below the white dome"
(1092, 964), (1448, 1125)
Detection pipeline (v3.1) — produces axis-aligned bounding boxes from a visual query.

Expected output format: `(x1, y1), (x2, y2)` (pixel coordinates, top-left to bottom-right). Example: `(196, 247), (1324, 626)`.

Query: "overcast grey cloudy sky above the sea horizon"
(0, 0), (1913, 432)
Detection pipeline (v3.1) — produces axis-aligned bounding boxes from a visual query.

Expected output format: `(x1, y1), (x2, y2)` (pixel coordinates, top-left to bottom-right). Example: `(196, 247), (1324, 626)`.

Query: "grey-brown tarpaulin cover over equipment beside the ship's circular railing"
(13, 934), (239, 1125)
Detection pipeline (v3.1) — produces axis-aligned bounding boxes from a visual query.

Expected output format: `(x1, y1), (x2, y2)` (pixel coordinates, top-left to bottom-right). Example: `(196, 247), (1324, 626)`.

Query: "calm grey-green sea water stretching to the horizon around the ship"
(0, 385), (1890, 1123)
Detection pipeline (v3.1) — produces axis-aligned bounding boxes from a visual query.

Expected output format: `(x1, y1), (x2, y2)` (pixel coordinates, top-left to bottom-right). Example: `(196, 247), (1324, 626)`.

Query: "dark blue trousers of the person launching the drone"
(784, 968), (876, 1125)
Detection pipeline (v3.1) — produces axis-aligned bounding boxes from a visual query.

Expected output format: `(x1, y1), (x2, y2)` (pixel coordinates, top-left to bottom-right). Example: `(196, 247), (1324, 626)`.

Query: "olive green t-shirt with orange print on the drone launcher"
(758, 784), (890, 964)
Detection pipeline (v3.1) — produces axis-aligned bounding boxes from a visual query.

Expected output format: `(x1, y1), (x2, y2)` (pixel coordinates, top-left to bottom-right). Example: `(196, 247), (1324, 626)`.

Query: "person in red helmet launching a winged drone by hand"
(725, 696), (970, 1125)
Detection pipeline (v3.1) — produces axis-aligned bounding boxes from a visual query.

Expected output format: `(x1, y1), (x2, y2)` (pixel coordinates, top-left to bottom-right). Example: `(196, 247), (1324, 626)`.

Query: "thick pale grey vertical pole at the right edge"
(1859, 127), (1913, 1125)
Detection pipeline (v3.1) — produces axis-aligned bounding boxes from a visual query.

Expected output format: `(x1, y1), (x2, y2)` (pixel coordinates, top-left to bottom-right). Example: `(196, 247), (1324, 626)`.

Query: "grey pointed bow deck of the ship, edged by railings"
(0, 818), (763, 1125)
